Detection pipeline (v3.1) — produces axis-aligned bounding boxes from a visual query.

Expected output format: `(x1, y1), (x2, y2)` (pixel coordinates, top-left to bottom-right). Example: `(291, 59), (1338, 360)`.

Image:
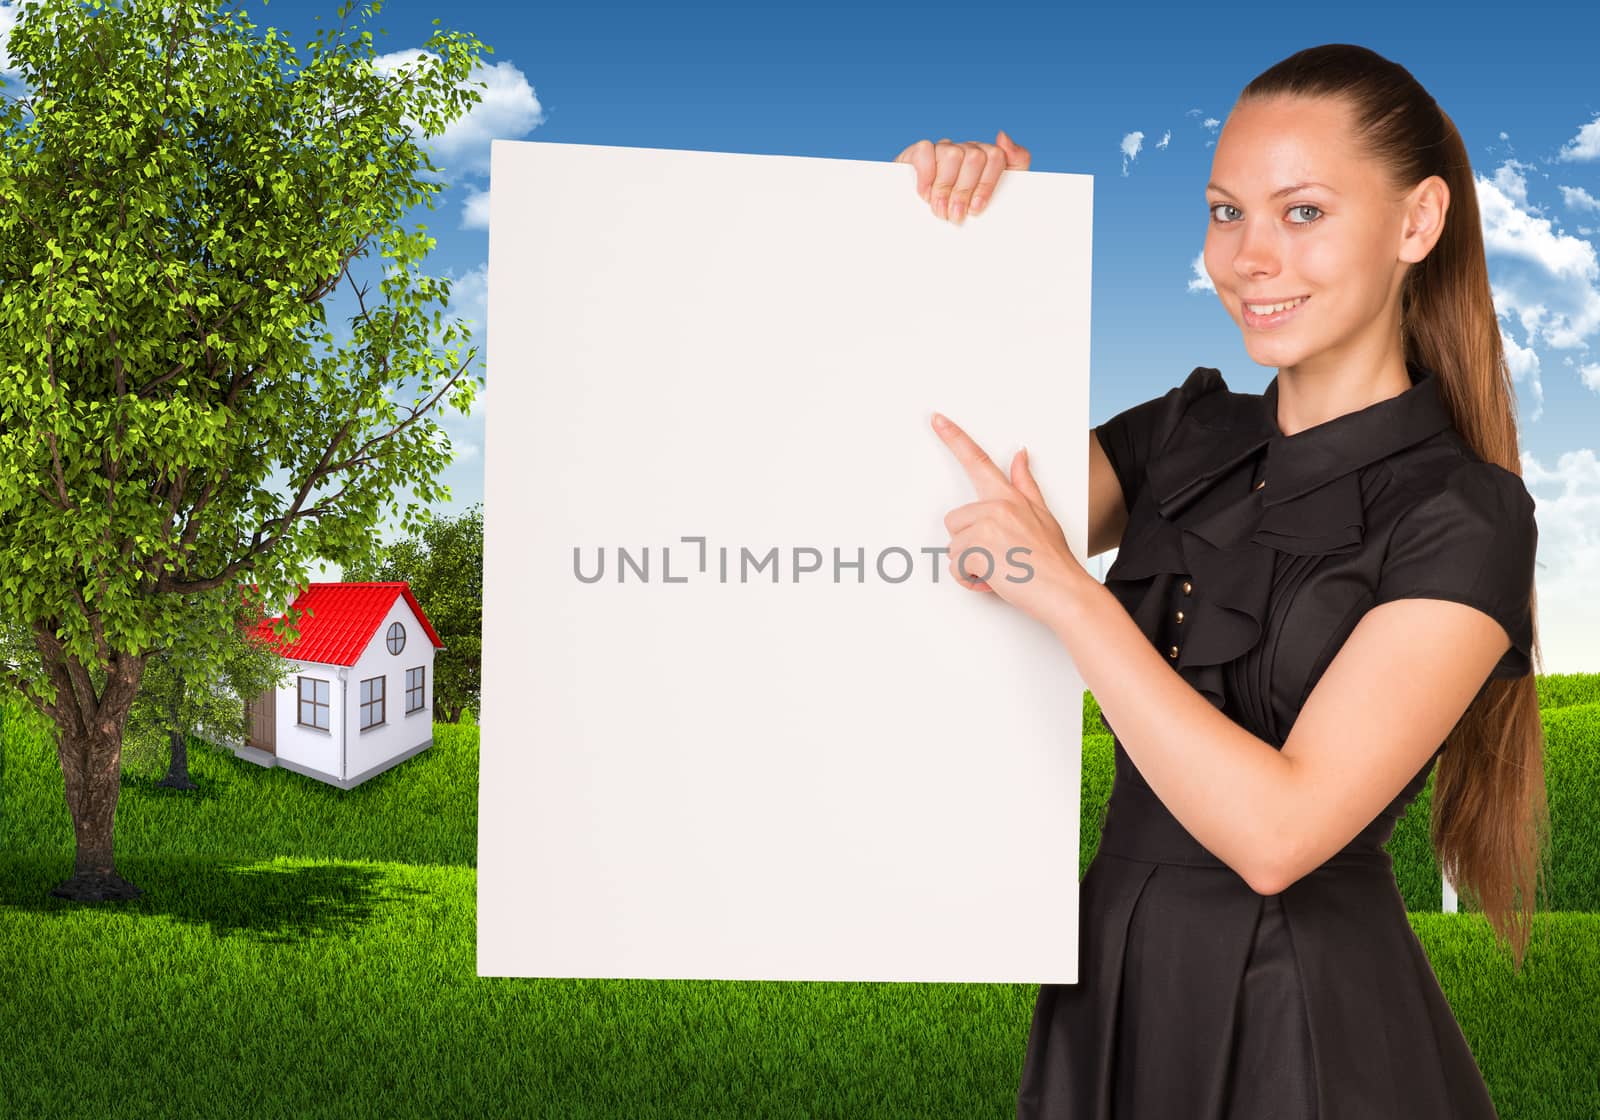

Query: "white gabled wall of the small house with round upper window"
(334, 595), (434, 778)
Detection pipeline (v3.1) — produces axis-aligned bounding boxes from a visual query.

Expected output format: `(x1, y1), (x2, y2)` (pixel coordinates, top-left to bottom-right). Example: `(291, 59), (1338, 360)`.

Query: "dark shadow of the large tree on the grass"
(0, 858), (430, 944)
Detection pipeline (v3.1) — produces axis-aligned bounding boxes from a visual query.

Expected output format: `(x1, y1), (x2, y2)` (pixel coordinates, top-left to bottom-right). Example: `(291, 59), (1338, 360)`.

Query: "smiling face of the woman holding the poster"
(1205, 98), (1443, 366)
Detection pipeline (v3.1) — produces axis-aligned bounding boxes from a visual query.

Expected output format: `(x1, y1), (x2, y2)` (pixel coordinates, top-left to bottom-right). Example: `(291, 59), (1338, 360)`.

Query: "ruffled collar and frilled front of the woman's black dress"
(1106, 363), (1453, 731)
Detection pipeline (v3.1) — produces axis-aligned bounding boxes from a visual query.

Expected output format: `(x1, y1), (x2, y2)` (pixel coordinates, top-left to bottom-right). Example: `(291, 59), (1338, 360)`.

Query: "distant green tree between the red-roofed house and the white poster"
(344, 502), (483, 723)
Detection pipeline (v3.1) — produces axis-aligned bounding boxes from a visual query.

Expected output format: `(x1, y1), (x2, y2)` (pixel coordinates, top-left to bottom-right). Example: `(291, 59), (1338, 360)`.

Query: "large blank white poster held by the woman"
(478, 141), (1093, 982)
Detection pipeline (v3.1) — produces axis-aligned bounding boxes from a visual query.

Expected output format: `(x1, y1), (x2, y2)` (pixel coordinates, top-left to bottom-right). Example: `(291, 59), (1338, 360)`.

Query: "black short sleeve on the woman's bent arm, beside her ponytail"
(1376, 461), (1539, 678)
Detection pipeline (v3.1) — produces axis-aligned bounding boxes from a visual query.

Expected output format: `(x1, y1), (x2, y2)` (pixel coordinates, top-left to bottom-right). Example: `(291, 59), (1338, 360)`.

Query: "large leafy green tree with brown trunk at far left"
(0, 0), (483, 899)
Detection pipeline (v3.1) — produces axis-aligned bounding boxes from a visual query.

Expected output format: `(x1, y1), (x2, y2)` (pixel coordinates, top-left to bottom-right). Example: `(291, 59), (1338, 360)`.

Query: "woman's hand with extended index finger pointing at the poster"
(933, 413), (1088, 624)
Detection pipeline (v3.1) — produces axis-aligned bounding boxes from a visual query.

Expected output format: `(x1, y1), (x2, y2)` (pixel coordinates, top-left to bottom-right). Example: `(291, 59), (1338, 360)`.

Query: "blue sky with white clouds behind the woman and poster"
(12, 0), (1600, 672)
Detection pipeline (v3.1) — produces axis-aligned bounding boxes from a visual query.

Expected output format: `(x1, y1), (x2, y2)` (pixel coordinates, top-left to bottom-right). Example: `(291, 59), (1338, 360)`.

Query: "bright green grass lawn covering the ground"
(0, 698), (1600, 1120)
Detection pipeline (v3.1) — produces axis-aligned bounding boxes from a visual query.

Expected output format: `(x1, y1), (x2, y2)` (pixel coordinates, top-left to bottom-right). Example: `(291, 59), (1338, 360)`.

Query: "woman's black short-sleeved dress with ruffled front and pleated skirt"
(1016, 365), (1536, 1120)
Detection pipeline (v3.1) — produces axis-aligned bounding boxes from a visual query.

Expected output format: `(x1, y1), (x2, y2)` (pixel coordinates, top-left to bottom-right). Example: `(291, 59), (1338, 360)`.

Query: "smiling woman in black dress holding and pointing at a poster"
(898, 45), (1547, 1120)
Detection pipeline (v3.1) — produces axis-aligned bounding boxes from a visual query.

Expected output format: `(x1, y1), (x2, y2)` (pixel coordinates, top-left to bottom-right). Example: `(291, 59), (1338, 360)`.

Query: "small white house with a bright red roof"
(229, 582), (445, 789)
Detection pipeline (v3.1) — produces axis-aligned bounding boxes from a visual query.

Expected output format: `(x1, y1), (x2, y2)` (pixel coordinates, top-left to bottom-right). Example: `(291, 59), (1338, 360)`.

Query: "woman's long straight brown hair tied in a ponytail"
(1238, 43), (1550, 971)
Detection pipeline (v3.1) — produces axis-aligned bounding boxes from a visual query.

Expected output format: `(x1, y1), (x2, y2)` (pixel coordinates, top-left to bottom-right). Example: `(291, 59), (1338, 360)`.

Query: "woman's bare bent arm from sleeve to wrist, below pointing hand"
(1045, 570), (1509, 894)
